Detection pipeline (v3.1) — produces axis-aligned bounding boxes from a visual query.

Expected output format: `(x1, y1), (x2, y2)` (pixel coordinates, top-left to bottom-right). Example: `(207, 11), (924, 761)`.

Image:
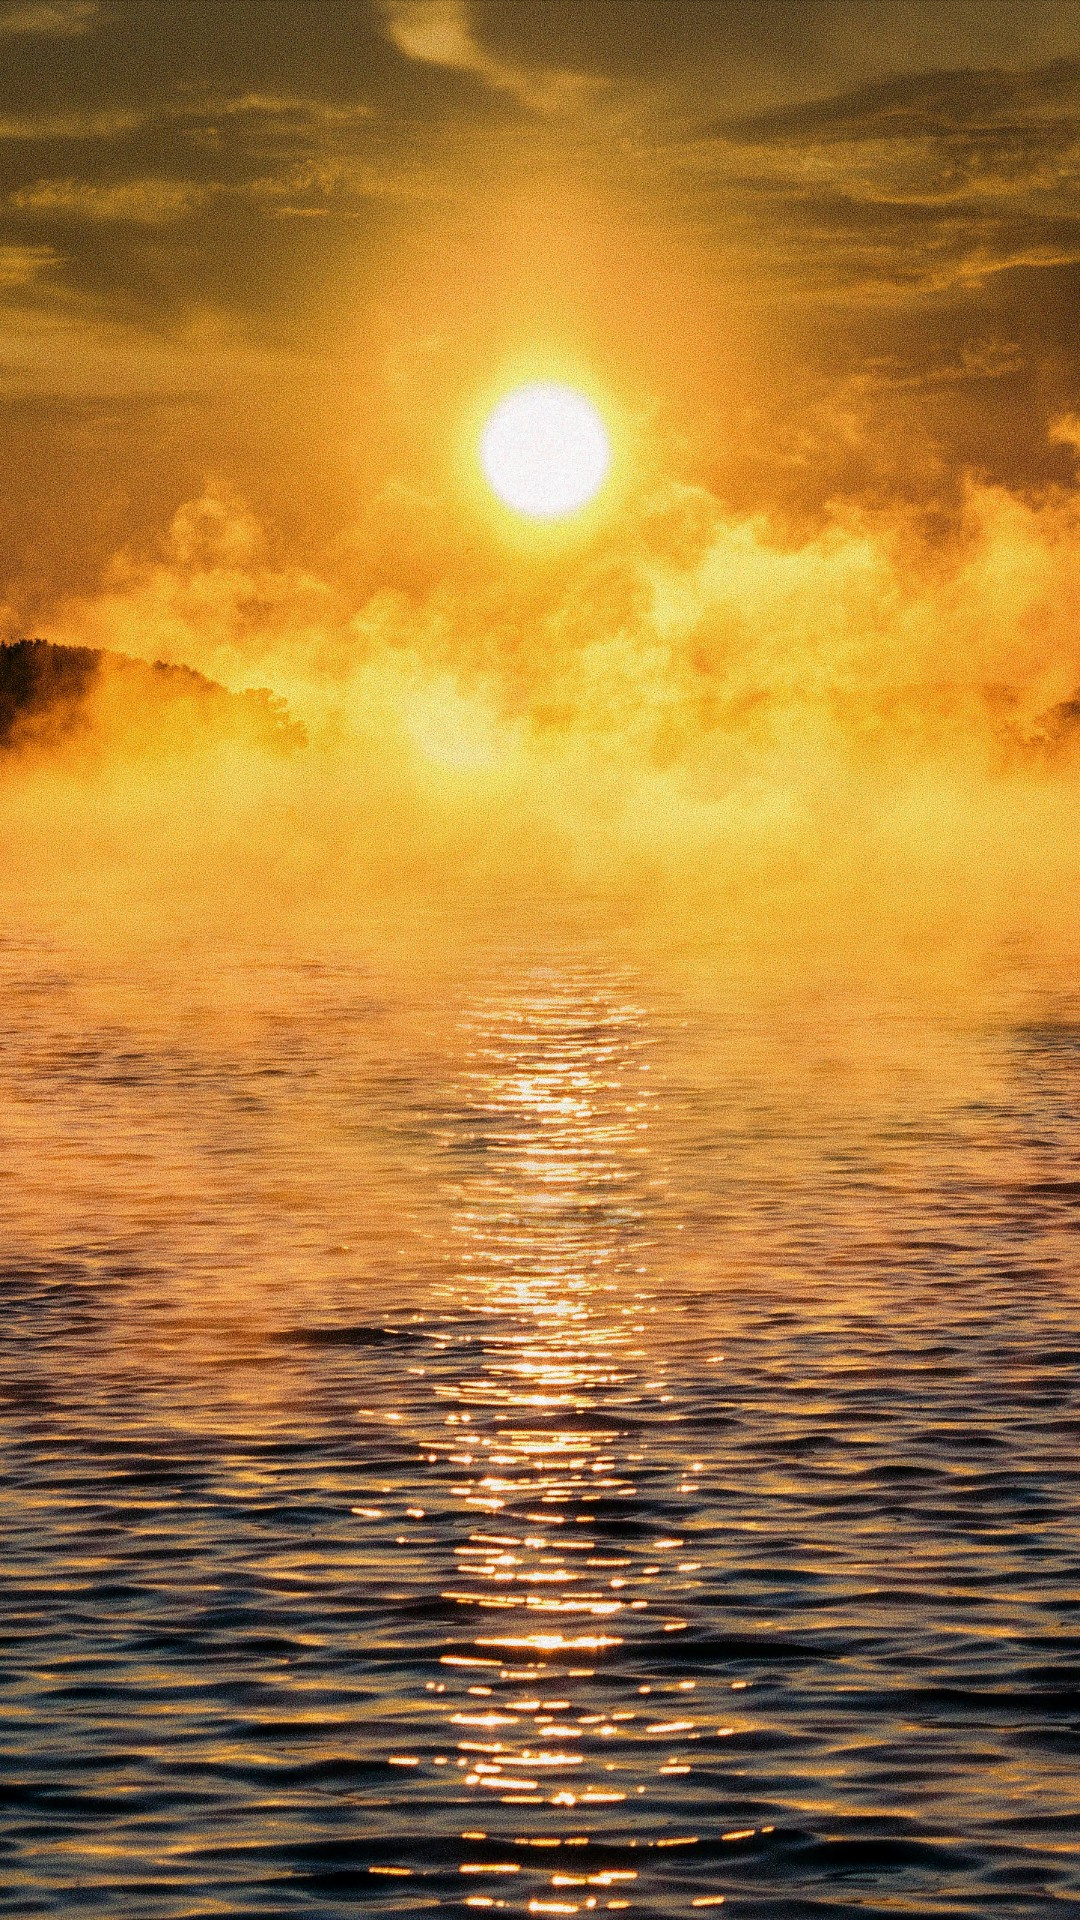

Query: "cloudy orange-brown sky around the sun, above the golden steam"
(0, 0), (1080, 606)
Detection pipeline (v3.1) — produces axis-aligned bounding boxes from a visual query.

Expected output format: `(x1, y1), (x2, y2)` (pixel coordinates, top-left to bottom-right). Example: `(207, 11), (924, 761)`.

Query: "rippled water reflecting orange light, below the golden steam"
(0, 921), (1080, 1920)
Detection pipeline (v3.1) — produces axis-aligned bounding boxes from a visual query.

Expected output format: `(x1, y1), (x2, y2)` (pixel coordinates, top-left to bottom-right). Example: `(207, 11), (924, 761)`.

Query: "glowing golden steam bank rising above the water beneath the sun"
(6, 472), (1080, 941)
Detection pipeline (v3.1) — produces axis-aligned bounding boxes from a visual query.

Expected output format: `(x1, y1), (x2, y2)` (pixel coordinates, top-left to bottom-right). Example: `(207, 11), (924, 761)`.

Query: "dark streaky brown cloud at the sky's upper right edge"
(669, 61), (1080, 290)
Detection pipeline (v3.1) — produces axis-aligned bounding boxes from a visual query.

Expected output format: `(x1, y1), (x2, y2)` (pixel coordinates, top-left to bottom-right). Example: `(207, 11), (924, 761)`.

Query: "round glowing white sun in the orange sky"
(480, 382), (611, 520)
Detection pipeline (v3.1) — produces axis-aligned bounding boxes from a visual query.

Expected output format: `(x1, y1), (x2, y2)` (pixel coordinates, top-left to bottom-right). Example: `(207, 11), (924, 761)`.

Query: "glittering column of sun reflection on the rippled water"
(405, 975), (696, 1873)
